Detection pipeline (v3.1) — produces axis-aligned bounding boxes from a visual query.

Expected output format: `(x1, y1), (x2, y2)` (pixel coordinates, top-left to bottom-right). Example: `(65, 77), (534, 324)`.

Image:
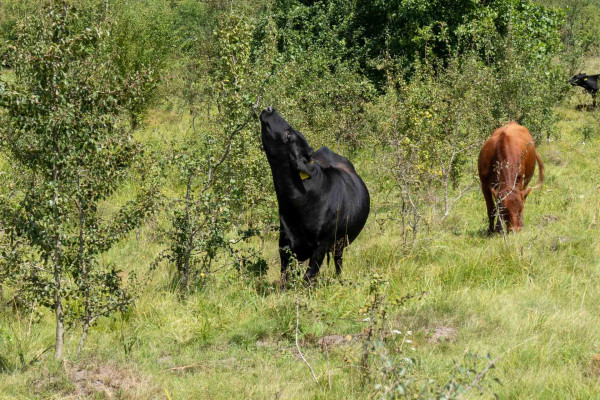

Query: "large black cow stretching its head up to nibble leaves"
(260, 107), (370, 281)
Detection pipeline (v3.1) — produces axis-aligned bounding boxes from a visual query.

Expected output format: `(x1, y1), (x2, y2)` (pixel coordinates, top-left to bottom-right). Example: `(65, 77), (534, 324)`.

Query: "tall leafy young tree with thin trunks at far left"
(0, 0), (156, 359)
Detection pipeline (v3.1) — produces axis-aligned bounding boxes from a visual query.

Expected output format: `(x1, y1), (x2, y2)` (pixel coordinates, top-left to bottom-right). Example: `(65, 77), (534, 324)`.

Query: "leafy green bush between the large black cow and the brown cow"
(369, 56), (500, 244)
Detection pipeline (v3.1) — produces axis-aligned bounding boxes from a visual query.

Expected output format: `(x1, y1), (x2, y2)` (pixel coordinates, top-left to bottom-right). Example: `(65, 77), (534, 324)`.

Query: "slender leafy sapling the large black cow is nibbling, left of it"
(156, 15), (272, 292)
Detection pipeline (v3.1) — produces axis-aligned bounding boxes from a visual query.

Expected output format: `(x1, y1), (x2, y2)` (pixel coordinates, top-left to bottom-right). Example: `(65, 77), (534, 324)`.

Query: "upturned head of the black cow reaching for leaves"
(260, 106), (315, 179)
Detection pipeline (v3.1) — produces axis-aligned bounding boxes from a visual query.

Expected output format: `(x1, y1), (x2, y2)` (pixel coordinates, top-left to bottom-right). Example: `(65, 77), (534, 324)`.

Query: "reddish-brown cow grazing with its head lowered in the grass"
(478, 121), (544, 233)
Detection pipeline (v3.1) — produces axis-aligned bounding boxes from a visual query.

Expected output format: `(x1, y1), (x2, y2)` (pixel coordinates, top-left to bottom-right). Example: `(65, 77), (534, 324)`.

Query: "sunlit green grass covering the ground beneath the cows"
(0, 97), (600, 399)
